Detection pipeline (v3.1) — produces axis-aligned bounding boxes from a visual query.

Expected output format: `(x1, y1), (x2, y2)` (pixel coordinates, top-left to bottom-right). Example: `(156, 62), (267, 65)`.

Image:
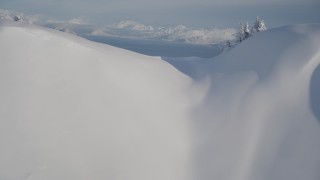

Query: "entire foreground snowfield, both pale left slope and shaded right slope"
(0, 23), (320, 180)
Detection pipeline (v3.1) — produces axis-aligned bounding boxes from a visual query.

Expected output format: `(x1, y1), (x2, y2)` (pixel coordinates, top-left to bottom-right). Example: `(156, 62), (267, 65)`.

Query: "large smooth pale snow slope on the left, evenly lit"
(0, 23), (195, 180)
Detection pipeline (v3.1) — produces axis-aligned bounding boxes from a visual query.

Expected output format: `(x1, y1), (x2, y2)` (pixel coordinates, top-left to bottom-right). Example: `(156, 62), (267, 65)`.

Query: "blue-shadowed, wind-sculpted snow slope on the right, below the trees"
(186, 25), (320, 180)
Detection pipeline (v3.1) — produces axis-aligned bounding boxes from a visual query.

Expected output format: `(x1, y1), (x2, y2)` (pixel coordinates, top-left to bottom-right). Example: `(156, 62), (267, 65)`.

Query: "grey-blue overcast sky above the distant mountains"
(0, 0), (320, 27)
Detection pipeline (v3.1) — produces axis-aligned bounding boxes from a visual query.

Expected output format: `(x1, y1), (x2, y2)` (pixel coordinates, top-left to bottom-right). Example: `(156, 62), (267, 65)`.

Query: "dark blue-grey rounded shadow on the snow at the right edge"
(309, 64), (320, 122)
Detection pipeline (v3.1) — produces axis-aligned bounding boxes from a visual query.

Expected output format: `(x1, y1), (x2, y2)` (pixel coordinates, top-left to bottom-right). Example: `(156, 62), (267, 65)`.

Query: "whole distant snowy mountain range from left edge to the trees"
(0, 9), (236, 45)
